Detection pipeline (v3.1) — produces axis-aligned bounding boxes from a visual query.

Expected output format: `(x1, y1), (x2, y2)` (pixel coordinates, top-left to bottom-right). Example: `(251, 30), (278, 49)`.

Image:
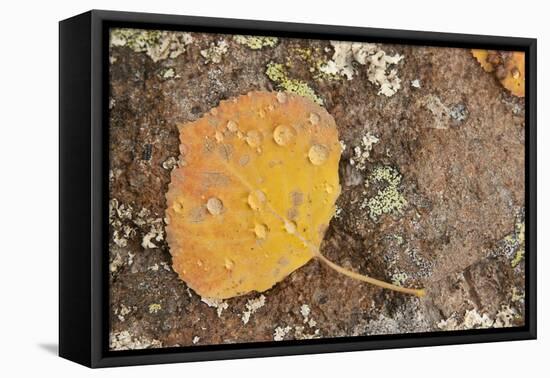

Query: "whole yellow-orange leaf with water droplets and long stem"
(166, 92), (422, 299)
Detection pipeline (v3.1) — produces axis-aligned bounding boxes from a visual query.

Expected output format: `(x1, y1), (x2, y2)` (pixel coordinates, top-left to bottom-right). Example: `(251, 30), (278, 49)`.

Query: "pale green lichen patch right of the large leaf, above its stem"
(362, 166), (407, 221)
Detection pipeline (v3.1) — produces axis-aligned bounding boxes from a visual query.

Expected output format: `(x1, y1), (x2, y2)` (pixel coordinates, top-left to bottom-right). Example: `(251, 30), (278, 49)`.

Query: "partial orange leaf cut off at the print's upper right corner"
(472, 49), (525, 97)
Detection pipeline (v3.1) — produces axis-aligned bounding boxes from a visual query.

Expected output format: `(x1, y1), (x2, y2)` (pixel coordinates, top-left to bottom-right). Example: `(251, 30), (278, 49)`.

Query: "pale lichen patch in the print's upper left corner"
(109, 28), (193, 62)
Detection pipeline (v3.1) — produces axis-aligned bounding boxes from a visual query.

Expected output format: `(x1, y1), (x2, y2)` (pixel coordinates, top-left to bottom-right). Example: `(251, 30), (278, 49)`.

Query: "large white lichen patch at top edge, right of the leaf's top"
(320, 41), (403, 97)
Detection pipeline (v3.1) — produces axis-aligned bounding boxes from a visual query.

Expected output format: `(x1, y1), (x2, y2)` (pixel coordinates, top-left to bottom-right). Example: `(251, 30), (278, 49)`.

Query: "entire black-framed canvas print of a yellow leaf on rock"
(59, 10), (536, 367)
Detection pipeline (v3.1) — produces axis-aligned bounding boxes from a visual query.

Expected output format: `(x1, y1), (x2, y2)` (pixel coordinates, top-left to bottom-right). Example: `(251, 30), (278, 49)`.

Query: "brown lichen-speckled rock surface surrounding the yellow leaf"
(109, 28), (525, 349)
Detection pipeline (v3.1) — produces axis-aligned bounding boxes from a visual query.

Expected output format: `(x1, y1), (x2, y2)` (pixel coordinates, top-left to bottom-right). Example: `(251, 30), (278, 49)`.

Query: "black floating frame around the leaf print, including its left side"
(59, 10), (537, 368)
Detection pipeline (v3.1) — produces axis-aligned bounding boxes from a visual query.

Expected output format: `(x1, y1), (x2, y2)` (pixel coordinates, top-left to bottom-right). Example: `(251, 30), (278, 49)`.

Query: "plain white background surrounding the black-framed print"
(0, 0), (550, 378)
